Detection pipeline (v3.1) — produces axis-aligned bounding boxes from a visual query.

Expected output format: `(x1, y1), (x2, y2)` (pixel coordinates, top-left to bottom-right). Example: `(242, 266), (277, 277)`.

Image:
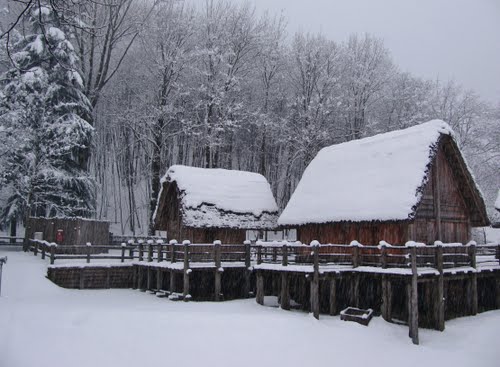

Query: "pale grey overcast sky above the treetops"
(190, 0), (500, 103)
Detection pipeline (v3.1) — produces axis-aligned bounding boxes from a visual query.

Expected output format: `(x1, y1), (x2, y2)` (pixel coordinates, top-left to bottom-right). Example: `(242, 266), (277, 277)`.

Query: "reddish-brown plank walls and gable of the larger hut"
(297, 145), (471, 245)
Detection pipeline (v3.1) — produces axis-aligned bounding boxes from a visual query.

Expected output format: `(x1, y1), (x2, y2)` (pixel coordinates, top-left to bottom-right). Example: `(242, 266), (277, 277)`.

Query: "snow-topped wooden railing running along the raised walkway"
(30, 239), (500, 269)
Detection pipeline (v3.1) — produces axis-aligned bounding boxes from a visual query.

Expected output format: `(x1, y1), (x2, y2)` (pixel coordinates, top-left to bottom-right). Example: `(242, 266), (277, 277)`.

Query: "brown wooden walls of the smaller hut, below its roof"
(156, 182), (246, 244)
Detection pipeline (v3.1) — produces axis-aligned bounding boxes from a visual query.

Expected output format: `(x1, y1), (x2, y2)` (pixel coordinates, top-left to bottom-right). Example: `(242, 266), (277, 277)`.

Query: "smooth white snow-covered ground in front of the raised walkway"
(0, 252), (500, 367)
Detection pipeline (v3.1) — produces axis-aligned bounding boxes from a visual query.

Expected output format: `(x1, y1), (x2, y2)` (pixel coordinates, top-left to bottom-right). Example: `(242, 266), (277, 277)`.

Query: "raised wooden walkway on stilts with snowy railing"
(31, 240), (500, 343)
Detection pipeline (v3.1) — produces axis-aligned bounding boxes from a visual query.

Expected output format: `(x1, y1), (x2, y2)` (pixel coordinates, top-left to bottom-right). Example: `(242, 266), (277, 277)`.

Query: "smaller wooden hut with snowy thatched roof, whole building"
(155, 165), (278, 243)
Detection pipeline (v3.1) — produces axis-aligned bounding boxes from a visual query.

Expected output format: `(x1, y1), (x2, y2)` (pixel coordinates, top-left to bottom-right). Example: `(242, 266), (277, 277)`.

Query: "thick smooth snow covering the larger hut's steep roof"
(278, 120), (480, 226)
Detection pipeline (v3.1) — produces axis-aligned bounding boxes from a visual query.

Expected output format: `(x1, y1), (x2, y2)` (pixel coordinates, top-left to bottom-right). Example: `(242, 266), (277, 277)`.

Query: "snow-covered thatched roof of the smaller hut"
(159, 165), (278, 229)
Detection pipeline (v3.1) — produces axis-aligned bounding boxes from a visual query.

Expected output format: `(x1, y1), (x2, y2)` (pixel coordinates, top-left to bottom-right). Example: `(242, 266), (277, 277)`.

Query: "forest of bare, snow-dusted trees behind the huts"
(2, 0), (500, 234)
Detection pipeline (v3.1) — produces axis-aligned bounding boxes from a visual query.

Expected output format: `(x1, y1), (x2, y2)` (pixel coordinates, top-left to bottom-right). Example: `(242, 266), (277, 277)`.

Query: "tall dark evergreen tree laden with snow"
(0, 4), (94, 233)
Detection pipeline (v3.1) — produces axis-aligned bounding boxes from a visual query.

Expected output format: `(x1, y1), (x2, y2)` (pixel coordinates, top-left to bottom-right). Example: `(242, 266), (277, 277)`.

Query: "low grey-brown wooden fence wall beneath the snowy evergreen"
(26, 218), (109, 246)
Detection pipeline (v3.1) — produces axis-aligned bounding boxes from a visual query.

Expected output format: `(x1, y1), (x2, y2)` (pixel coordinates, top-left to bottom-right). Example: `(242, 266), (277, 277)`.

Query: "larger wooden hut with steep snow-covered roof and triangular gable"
(278, 120), (489, 244)
